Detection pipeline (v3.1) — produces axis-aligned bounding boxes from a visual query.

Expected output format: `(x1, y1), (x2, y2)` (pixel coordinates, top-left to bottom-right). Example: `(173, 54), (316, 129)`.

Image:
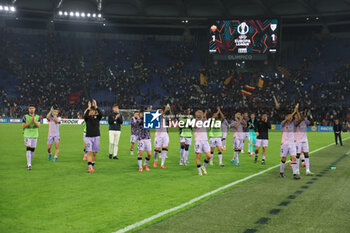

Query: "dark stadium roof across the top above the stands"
(5, 0), (350, 27)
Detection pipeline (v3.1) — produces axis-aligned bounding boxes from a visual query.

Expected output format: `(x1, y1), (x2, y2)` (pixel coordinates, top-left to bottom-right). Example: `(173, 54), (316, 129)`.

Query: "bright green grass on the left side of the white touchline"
(0, 124), (345, 232)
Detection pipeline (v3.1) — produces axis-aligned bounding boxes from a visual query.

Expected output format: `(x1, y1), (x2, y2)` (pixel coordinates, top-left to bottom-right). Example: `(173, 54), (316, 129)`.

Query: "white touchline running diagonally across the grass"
(114, 137), (350, 233)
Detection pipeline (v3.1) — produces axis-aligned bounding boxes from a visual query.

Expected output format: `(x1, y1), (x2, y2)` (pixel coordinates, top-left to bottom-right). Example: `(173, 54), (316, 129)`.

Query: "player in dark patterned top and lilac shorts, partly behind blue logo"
(137, 107), (152, 172)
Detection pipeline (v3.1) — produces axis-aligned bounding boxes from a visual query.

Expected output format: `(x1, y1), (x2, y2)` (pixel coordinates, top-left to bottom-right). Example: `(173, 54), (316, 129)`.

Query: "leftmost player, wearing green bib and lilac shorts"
(22, 104), (40, 170)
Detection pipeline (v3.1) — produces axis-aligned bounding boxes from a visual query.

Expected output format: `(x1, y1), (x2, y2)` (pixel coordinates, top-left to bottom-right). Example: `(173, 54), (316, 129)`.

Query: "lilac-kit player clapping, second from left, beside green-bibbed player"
(46, 107), (61, 162)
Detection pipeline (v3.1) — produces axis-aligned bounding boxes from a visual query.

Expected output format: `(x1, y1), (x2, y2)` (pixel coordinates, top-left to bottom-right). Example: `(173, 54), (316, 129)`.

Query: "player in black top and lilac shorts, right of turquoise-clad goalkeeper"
(254, 114), (271, 165)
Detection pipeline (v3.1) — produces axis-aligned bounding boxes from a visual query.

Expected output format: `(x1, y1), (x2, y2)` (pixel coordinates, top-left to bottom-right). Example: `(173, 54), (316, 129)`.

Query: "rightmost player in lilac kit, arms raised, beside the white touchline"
(295, 111), (313, 176)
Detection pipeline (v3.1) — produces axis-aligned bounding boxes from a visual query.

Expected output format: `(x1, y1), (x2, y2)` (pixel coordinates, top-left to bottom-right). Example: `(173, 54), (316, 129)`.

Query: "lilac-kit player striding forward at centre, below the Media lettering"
(193, 110), (211, 176)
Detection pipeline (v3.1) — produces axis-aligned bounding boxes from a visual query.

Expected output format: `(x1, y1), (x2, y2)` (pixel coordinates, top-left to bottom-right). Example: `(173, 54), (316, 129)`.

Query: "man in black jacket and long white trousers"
(108, 104), (123, 159)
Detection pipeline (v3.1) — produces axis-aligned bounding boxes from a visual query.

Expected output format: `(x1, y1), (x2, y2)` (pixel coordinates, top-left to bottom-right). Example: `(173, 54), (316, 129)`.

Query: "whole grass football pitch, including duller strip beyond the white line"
(0, 124), (350, 233)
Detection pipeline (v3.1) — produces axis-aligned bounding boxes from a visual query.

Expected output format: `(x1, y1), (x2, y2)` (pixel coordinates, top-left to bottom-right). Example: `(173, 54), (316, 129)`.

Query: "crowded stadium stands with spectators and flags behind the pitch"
(0, 28), (350, 122)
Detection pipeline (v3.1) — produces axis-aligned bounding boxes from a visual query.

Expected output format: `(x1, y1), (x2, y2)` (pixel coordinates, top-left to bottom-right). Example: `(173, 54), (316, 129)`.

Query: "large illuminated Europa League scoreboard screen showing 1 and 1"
(208, 19), (279, 54)
